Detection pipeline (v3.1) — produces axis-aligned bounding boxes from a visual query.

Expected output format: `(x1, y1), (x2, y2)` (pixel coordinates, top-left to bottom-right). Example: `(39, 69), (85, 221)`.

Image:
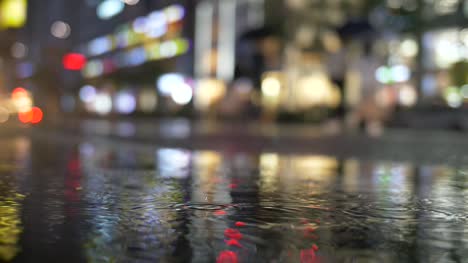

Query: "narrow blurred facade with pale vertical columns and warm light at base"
(194, 0), (266, 118)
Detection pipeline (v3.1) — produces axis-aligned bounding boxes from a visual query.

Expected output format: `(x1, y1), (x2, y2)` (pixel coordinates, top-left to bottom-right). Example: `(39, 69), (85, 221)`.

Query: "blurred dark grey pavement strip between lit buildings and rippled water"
(39, 116), (468, 164)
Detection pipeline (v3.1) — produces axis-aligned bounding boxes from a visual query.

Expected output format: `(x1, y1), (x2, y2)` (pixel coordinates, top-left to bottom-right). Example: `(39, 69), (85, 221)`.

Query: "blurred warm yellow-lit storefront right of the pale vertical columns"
(252, 0), (468, 124)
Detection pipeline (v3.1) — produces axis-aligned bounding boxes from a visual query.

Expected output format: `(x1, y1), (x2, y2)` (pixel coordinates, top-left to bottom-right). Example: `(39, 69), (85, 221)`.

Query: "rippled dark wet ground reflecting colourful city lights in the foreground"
(0, 138), (468, 262)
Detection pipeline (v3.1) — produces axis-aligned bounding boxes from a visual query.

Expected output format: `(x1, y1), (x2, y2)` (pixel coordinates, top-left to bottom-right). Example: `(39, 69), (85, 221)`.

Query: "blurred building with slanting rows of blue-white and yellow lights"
(75, 2), (193, 116)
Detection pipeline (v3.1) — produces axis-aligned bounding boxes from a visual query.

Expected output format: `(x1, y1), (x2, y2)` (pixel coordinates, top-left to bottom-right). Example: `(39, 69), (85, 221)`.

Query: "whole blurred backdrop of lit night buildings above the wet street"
(0, 0), (468, 126)
